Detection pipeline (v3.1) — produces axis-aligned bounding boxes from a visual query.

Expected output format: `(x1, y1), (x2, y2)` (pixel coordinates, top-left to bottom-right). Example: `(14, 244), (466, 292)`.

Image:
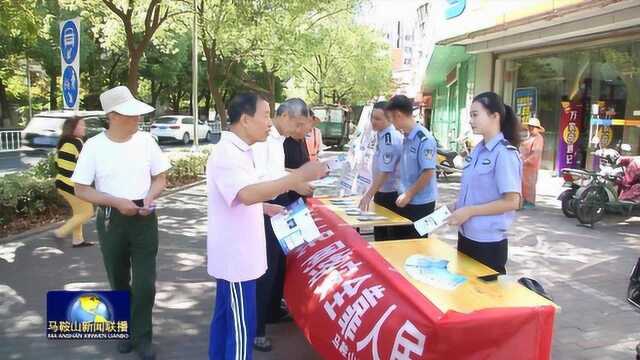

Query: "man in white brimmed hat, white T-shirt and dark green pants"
(72, 86), (171, 359)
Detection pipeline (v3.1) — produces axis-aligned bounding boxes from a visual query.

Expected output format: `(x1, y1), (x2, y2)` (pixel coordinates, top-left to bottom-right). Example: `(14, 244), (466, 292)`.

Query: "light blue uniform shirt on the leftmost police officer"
(372, 125), (402, 192)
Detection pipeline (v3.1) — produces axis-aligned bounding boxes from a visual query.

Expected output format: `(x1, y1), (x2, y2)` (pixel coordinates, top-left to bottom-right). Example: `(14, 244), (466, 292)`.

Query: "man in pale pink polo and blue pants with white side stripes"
(207, 93), (327, 360)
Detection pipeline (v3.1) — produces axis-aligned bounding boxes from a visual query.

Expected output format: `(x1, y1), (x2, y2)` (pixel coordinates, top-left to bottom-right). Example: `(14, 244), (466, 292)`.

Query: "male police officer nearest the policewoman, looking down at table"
(387, 95), (438, 239)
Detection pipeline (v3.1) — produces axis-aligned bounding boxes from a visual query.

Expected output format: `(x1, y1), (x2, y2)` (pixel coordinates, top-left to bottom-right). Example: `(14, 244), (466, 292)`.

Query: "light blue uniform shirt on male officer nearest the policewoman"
(400, 124), (438, 205)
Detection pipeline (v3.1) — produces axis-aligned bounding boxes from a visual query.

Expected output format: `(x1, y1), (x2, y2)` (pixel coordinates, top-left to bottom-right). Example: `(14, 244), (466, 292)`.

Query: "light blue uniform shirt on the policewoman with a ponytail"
(456, 133), (522, 242)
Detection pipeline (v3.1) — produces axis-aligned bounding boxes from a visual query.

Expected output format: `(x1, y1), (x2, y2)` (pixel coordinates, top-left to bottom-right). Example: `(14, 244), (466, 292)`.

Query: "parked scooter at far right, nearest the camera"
(575, 144), (640, 226)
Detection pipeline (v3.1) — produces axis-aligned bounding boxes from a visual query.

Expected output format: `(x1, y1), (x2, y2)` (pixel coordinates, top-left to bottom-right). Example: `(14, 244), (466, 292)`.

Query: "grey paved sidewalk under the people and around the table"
(0, 174), (640, 360)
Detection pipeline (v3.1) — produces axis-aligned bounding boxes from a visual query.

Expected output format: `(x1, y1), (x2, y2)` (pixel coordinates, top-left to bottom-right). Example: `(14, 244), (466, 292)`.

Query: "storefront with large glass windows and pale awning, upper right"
(423, 0), (640, 169)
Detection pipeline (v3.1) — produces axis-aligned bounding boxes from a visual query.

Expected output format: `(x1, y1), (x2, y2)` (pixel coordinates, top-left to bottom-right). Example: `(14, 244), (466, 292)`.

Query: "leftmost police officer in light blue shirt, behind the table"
(360, 101), (402, 241)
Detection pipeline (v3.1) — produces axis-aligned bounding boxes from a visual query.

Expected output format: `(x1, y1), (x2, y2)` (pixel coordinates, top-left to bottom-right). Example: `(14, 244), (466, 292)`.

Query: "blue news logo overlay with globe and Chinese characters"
(46, 291), (130, 340)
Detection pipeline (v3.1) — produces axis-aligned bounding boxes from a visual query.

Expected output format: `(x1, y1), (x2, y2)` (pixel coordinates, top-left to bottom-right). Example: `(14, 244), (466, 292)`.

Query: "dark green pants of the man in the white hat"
(96, 207), (158, 345)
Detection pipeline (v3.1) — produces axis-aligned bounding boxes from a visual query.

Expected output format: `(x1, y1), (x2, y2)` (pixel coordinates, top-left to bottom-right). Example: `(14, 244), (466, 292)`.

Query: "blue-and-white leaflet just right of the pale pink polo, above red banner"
(271, 199), (320, 254)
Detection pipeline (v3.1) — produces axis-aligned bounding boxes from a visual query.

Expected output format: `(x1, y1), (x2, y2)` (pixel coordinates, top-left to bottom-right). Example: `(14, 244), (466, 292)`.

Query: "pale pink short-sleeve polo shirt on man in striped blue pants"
(207, 131), (267, 282)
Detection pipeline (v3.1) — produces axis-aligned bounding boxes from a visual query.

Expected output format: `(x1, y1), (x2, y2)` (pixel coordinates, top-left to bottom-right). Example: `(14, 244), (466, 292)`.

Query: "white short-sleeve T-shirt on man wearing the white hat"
(71, 131), (171, 200)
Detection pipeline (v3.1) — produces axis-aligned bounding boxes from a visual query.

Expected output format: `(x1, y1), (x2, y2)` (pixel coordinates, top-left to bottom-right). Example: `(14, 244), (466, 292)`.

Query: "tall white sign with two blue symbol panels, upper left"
(60, 18), (80, 110)
